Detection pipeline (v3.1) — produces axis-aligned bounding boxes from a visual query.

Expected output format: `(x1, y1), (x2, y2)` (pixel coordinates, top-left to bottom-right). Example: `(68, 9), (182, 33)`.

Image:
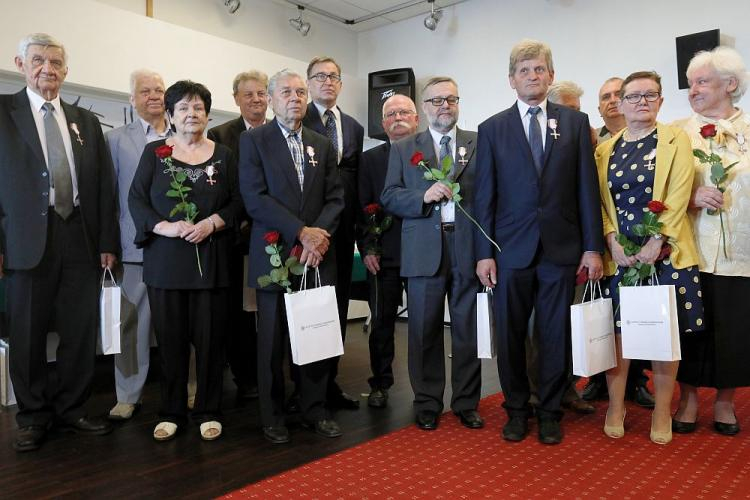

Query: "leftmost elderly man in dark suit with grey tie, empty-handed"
(0, 33), (119, 451)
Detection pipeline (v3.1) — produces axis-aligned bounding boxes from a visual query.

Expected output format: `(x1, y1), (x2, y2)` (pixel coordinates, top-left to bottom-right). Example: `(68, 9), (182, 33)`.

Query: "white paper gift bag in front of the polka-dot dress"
(620, 285), (681, 361)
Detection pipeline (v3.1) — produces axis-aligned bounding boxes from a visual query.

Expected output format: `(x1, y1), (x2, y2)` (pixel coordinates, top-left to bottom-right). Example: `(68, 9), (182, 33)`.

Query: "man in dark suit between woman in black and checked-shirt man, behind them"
(208, 70), (268, 400)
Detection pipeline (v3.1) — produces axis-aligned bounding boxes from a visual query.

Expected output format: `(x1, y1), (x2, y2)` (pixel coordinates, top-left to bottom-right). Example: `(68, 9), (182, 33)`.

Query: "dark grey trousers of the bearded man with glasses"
(407, 232), (482, 413)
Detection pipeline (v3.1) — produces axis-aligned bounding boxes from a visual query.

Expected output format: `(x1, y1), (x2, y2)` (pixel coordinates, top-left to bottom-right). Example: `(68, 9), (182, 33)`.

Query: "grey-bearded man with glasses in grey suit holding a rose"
(382, 77), (484, 430)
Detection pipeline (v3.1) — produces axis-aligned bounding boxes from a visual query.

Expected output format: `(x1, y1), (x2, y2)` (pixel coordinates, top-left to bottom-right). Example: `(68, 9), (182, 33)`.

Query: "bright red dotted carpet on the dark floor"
(225, 389), (750, 499)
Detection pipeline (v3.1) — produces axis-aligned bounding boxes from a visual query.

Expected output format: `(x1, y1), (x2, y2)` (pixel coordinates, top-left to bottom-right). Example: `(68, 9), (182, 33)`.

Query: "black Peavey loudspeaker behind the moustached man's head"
(367, 68), (416, 141)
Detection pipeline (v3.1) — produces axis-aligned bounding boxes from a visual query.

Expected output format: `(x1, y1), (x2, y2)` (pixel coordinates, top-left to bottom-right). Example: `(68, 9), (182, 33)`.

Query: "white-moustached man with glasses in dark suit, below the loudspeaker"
(357, 94), (419, 408)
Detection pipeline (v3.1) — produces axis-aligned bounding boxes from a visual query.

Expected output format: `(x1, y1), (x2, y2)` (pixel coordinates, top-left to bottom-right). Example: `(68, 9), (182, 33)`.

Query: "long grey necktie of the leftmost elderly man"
(42, 102), (73, 219)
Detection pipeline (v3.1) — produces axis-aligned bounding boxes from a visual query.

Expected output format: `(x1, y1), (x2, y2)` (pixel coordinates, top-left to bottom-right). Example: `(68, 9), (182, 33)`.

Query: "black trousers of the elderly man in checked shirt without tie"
(256, 289), (331, 427)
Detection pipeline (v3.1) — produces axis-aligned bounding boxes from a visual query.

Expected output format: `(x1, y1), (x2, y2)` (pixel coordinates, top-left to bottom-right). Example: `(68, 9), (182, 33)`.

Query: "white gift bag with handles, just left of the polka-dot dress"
(570, 281), (617, 377)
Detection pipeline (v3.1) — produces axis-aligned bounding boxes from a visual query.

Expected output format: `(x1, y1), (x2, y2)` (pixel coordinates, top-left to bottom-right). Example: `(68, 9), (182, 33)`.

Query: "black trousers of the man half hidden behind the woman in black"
(226, 249), (258, 389)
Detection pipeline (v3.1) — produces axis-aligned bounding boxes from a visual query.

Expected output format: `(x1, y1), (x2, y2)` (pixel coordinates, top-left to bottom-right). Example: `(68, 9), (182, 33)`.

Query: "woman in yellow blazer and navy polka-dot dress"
(596, 71), (703, 444)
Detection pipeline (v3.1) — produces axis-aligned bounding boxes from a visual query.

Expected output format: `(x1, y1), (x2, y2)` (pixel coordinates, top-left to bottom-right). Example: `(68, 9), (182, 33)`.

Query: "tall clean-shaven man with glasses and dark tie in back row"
(304, 56), (365, 410)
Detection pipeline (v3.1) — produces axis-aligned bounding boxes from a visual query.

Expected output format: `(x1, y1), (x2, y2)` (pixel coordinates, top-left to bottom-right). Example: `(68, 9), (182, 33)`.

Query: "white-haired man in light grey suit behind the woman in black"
(105, 69), (170, 420)
